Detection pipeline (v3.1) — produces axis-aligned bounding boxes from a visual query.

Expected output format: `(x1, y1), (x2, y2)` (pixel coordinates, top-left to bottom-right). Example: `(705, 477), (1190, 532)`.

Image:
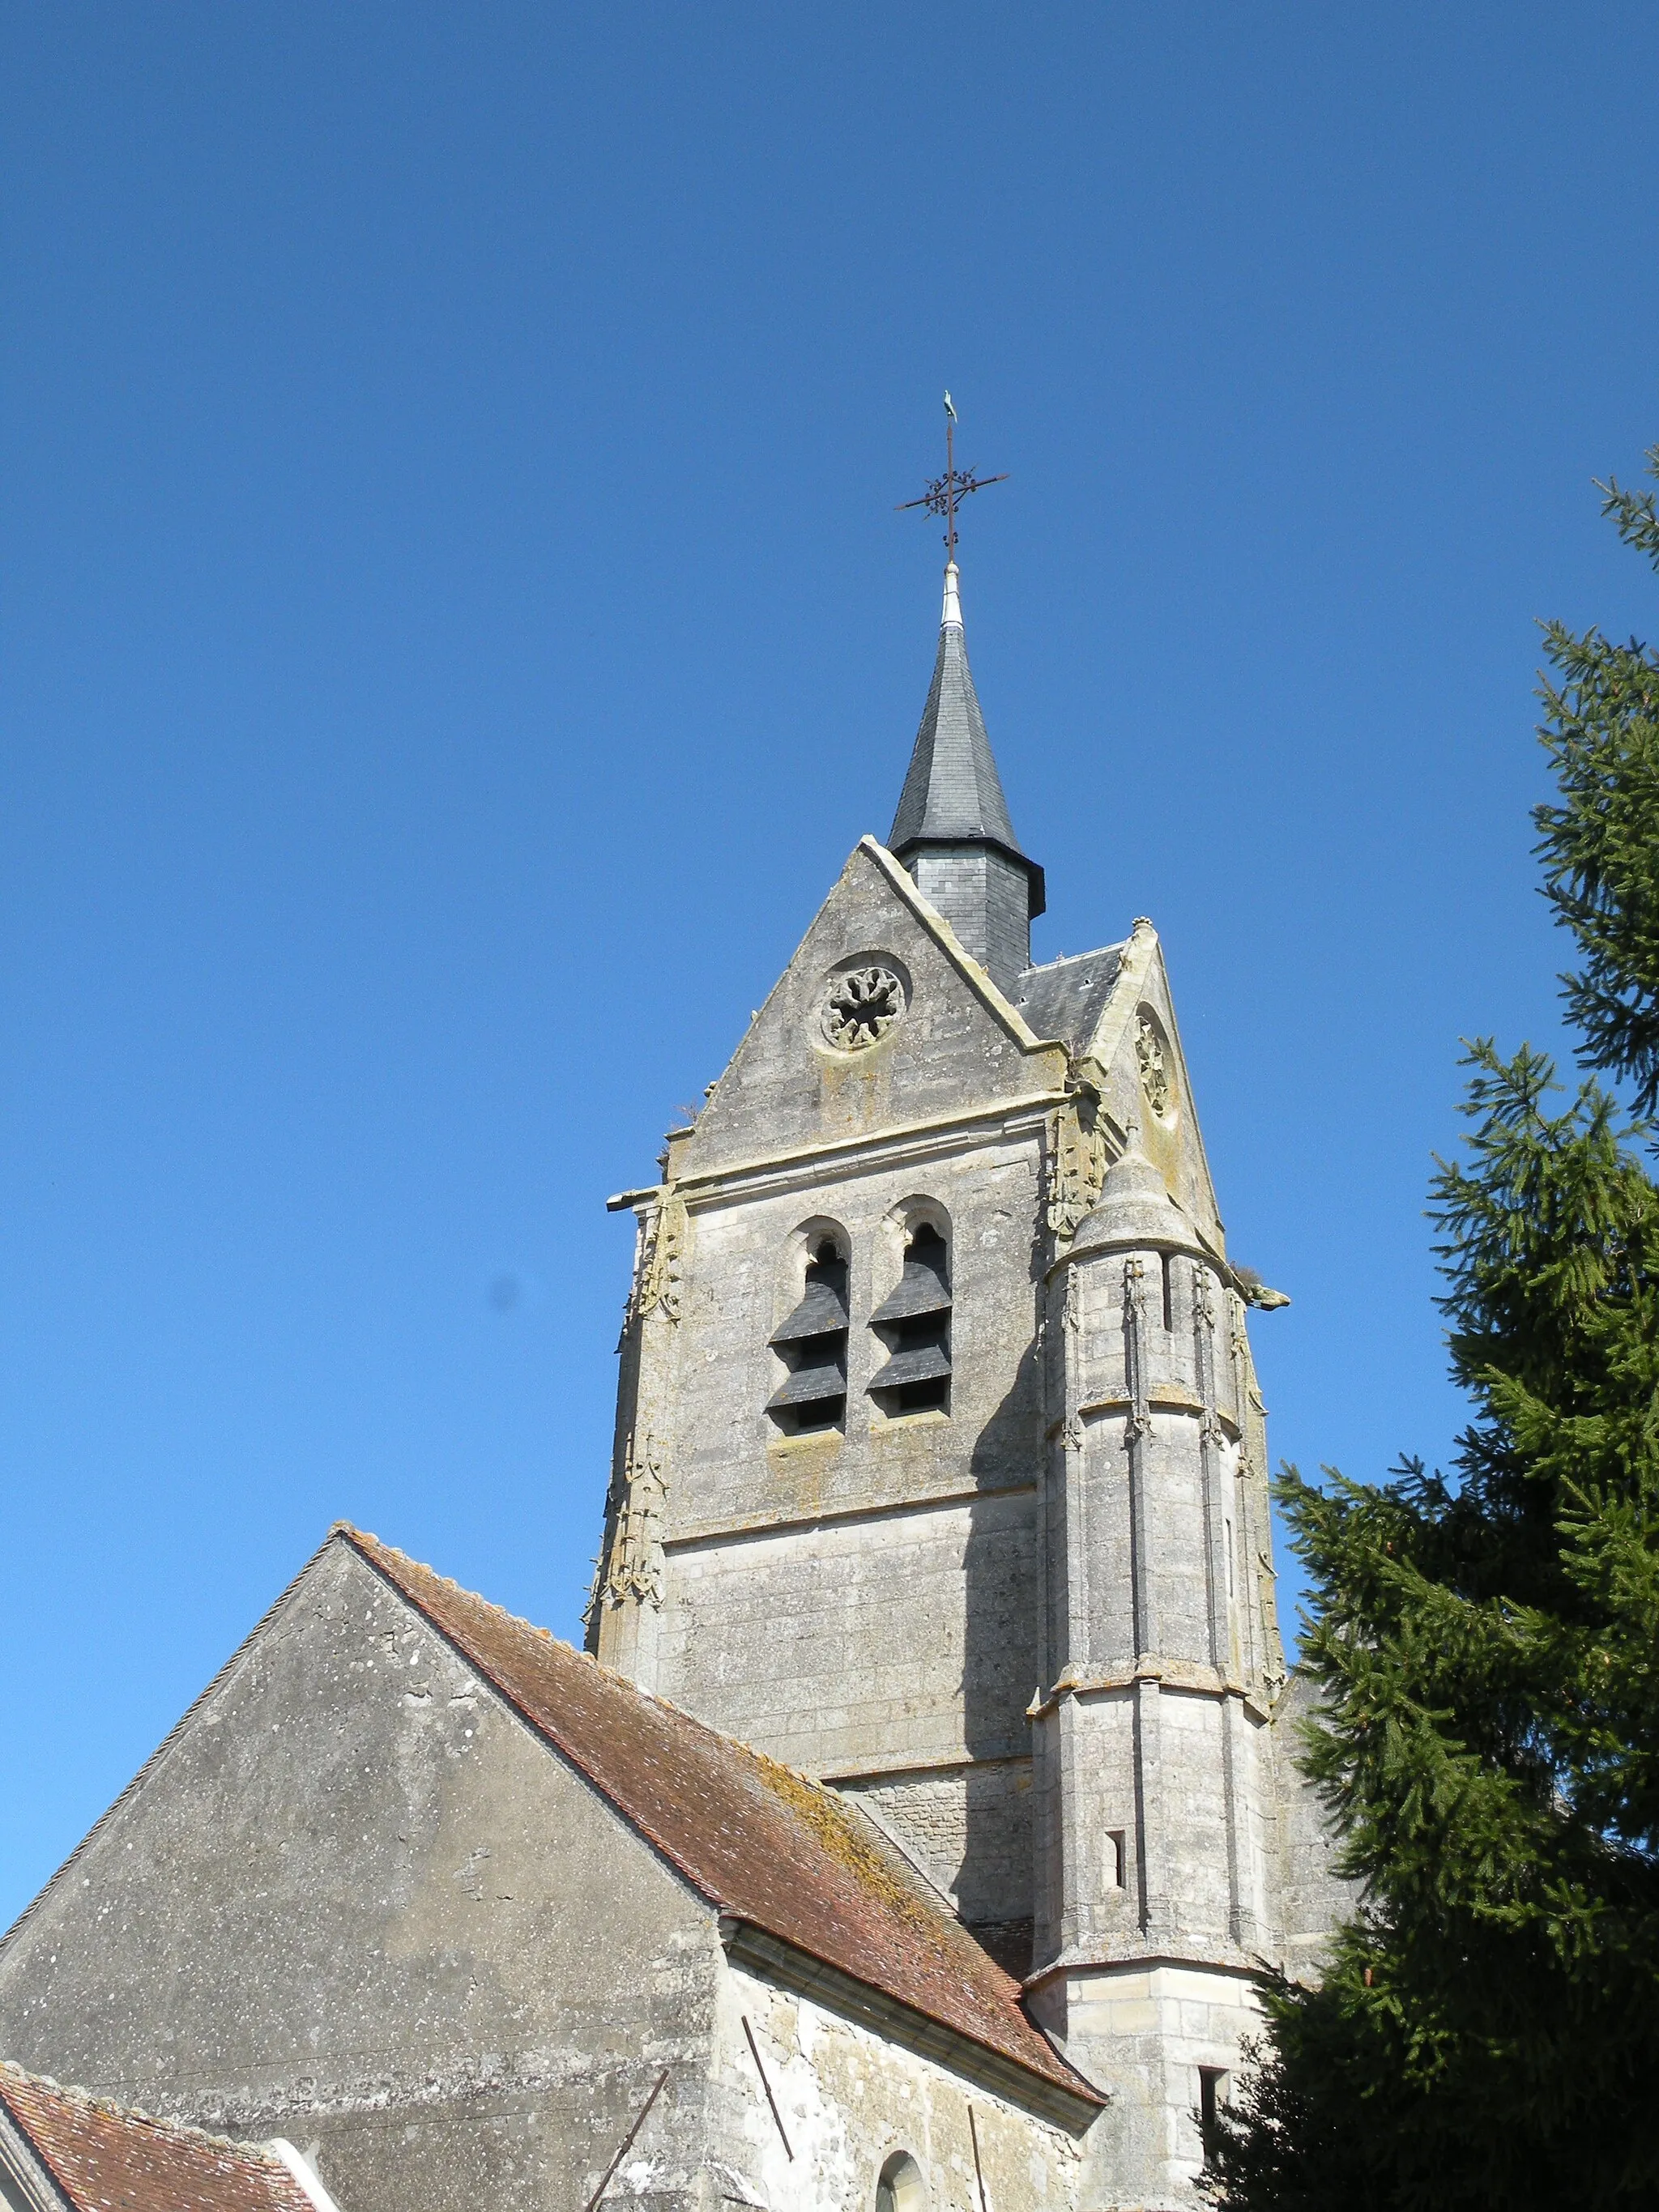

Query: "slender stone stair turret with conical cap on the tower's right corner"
(1026, 1132), (1286, 2201)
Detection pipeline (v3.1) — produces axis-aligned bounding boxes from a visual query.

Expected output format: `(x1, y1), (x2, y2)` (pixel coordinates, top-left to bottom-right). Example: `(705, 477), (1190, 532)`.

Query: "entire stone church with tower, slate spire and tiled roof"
(0, 548), (1343, 2212)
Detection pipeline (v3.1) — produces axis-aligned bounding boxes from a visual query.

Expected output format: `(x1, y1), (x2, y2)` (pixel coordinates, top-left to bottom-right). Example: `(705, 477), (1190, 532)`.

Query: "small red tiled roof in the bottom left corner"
(0, 2064), (314, 2212)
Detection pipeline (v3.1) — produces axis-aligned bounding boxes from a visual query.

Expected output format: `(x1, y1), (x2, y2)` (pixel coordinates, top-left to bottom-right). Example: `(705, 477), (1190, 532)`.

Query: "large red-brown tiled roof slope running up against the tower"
(336, 1524), (1102, 2103)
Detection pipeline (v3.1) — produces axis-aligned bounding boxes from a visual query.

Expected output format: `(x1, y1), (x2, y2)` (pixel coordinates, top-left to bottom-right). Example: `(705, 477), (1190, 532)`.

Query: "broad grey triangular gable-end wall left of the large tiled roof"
(0, 1546), (719, 2212)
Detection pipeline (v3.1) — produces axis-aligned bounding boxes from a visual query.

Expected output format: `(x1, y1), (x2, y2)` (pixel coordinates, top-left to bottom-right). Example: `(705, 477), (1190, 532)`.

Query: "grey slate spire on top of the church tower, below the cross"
(887, 562), (1044, 989)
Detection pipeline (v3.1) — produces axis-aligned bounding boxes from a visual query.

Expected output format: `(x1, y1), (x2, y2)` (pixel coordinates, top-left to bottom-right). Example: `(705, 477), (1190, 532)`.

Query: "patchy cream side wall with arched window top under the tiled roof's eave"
(710, 1967), (1099, 2212)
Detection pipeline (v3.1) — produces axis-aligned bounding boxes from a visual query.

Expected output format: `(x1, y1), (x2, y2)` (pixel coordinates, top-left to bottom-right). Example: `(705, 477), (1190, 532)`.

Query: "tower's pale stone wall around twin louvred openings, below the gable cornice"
(653, 1122), (1042, 1920)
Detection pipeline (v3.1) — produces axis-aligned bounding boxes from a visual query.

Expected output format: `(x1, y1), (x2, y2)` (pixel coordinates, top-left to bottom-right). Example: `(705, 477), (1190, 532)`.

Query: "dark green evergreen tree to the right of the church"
(1208, 449), (1659, 2212)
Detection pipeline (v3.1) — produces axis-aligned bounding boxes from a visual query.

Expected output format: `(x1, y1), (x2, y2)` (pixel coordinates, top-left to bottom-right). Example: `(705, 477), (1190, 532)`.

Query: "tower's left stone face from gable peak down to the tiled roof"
(597, 847), (1079, 1922)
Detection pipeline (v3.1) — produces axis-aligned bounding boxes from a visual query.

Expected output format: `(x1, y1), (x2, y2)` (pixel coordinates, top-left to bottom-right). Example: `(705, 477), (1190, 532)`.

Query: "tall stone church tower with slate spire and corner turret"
(588, 539), (1325, 2208)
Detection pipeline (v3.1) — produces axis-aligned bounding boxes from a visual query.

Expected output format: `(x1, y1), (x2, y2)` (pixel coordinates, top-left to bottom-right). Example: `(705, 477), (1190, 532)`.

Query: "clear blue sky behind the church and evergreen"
(0, 0), (1659, 1920)
